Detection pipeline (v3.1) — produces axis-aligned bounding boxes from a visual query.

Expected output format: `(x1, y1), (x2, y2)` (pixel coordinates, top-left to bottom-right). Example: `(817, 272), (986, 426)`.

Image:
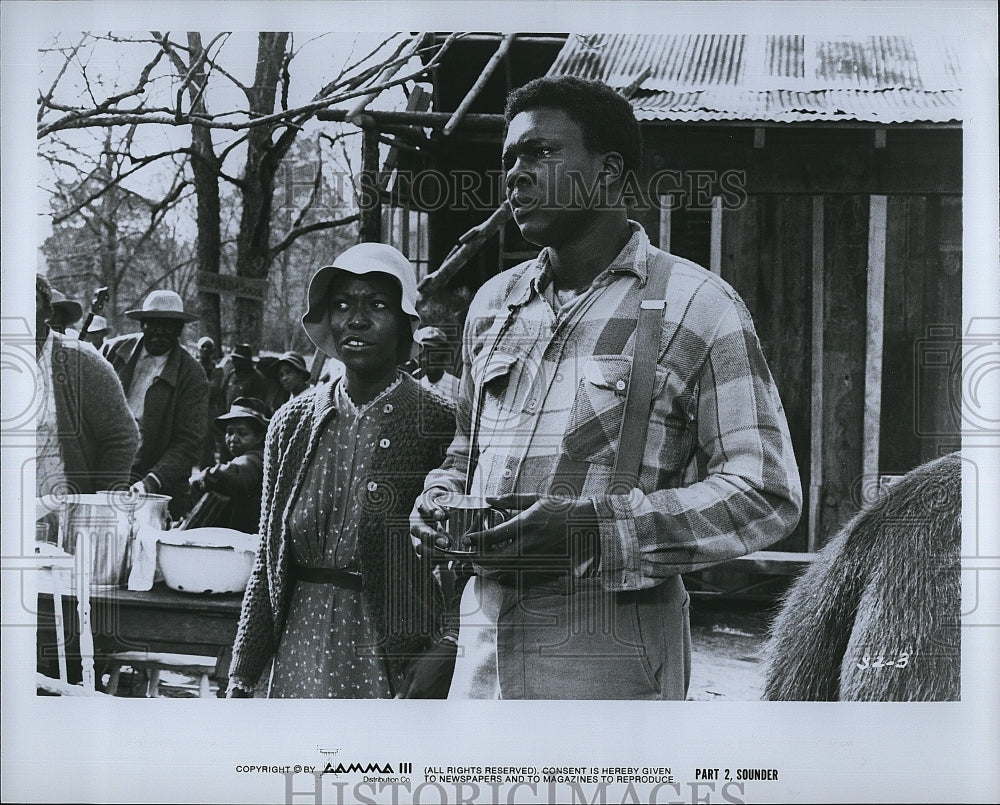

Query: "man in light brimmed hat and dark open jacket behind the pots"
(102, 290), (208, 518)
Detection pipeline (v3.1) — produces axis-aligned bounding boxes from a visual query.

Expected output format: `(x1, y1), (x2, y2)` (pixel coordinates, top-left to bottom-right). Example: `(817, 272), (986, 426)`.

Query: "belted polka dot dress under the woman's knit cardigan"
(268, 380), (399, 699)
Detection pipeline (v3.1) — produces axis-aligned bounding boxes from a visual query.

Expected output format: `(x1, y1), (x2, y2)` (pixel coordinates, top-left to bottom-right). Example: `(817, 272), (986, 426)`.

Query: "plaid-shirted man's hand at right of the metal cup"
(468, 495), (600, 572)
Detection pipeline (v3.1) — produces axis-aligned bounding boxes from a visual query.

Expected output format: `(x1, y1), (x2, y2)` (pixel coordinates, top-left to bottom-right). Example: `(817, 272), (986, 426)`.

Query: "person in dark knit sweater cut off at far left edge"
(35, 274), (139, 496)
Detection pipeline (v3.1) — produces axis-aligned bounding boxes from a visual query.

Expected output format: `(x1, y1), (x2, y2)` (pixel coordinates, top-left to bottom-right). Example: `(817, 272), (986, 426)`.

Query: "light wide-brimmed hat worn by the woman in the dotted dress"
(302, 243), (420, 361)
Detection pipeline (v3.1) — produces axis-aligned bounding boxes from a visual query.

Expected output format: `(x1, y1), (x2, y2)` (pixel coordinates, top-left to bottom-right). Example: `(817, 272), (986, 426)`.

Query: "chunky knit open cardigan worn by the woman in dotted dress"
(230, 375), (455, 686)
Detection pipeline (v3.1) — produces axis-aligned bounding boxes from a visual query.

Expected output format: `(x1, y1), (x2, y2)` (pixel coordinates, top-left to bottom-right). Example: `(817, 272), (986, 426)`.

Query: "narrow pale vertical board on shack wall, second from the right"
(806, 196), (825, 553)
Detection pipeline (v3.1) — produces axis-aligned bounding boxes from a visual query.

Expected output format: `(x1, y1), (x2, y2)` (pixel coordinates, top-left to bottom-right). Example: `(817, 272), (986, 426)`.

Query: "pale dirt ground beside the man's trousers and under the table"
(118, 595), (772, 701)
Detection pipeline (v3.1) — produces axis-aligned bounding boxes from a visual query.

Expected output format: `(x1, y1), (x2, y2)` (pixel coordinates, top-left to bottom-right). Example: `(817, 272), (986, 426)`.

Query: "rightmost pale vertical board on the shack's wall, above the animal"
(861, 196), (886, 500)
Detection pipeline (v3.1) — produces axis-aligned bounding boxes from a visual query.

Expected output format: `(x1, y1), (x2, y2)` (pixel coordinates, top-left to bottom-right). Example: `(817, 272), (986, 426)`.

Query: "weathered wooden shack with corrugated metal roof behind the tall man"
(320, 33), (962, 551)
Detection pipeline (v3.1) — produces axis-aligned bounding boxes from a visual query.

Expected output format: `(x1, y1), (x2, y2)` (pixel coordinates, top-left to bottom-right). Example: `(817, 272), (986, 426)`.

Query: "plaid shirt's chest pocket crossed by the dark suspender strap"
(562, 355), (695, 478)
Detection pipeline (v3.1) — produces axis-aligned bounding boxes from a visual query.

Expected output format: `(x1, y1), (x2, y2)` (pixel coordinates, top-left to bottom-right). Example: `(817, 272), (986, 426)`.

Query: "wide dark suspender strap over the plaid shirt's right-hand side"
(609, 260), (670, 494)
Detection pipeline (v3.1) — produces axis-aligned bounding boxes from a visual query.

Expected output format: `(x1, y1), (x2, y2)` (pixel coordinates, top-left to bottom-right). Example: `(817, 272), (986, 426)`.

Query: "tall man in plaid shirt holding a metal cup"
(411, 77), (802, 699)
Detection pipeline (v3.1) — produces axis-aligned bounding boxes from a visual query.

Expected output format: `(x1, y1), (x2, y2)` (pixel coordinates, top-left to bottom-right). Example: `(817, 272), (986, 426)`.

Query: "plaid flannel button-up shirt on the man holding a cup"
(425, 222), (802, 591)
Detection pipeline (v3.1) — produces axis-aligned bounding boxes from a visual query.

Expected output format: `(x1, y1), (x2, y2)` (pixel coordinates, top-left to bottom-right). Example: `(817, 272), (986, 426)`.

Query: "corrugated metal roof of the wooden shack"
(549, 34), (961, 124)
